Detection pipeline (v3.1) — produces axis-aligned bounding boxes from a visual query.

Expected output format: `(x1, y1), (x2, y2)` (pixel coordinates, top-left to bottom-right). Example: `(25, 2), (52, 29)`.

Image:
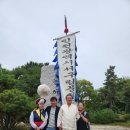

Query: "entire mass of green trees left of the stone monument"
(0, 62), (45, 130)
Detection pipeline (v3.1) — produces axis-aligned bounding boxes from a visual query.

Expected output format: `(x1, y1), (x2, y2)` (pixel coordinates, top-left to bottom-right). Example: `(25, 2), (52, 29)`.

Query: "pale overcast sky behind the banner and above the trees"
(0, 0), (130, 88)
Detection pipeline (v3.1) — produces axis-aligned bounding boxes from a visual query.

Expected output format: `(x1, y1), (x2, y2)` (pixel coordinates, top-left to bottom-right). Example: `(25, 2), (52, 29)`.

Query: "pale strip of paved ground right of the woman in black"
(90, 125), (130, 130)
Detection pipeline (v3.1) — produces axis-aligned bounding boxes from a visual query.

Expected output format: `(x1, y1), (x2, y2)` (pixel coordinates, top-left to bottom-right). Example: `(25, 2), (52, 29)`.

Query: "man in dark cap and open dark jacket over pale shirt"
(45, 97), (60, 130)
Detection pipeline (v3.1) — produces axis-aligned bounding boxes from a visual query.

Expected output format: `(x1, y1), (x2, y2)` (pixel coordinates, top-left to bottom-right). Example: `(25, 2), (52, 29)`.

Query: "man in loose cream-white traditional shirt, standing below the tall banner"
(57, 94), (79, 130)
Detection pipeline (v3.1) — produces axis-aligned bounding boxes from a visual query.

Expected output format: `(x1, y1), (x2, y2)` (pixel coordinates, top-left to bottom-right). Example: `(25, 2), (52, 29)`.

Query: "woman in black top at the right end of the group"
(77, 101), (90, 130)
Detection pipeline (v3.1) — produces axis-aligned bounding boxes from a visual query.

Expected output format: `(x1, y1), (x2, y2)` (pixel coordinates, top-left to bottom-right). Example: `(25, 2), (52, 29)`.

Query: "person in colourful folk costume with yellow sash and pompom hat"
(30, 98), (48, 130)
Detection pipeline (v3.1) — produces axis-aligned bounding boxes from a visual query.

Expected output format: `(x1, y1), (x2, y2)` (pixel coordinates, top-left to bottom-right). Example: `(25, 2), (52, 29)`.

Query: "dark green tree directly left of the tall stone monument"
(12, 61), (44, 97)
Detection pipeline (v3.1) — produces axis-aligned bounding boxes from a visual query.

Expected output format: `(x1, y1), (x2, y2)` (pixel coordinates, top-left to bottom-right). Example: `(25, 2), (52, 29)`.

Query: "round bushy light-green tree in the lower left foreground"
(0, 89), (33, 130)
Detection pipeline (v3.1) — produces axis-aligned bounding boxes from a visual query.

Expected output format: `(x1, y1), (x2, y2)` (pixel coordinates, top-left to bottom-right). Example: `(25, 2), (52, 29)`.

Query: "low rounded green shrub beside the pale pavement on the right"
(91, 109), (116, 124)
